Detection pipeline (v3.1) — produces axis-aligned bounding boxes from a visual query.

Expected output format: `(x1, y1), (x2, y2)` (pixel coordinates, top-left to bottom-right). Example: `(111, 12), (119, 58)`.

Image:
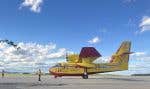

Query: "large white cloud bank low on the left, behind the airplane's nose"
(0, 42), (66, 71)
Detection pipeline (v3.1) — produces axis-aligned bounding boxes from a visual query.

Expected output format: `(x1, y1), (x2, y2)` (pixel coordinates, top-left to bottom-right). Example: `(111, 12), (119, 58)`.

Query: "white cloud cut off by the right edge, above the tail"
(139, 16), (150, 32)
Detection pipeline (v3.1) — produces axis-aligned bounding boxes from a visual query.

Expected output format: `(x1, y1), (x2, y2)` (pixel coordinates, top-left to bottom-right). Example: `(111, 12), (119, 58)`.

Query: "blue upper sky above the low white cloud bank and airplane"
(0, 0), (150, 73)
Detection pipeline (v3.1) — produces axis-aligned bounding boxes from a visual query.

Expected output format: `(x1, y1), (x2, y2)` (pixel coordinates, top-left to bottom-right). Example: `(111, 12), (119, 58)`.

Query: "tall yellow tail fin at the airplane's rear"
(110, 41), (131, 70)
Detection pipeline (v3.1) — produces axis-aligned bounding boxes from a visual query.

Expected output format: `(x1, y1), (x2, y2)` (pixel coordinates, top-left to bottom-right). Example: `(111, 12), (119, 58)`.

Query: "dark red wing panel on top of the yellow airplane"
(79, 47), (101, 58)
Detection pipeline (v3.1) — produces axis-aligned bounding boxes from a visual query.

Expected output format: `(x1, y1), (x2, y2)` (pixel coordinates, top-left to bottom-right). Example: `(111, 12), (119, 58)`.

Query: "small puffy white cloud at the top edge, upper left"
(20, 0), (43, 13)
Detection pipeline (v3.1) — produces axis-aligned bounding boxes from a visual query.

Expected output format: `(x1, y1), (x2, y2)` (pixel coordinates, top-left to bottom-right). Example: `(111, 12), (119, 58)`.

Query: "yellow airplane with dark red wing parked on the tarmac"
(49, 41), (132, 79)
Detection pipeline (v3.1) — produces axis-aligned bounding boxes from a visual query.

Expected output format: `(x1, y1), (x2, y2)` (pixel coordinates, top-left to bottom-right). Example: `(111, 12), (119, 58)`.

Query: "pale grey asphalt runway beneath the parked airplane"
(0, 75), (150, 89)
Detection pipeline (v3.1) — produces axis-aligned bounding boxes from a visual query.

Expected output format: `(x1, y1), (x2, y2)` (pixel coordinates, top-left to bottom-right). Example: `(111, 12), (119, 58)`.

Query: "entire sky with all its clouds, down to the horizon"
(0, 0), (150, 74)
